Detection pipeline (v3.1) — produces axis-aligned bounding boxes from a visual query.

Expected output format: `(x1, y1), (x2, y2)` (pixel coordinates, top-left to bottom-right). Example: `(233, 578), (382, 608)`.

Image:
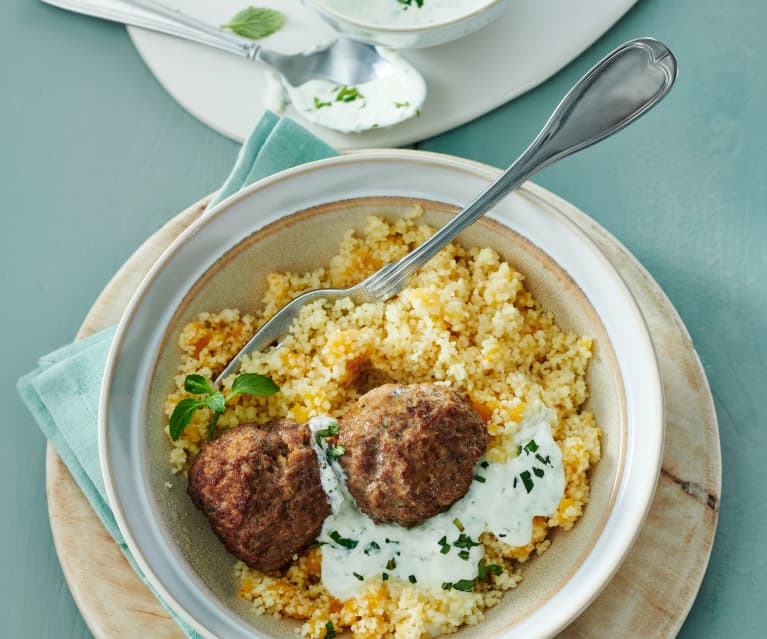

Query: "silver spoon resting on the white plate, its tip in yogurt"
(43, 0), (393, 87)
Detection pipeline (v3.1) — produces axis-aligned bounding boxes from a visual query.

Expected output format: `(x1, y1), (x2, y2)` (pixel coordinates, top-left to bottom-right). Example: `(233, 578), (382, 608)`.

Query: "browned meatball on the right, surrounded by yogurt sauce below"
(338, 384), (488, 527)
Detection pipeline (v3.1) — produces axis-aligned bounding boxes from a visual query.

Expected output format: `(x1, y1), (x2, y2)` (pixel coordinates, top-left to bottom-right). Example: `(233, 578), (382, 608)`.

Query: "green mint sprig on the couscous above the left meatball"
(170, 373), (280, 441)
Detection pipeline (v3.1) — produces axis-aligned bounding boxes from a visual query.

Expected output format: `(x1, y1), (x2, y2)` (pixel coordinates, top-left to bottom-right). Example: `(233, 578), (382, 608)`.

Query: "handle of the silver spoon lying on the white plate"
(43, 0), (261, 59)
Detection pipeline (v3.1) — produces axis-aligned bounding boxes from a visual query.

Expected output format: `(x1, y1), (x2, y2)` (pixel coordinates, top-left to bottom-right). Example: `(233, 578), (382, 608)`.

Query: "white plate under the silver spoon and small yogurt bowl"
(129, 0), (636, 149)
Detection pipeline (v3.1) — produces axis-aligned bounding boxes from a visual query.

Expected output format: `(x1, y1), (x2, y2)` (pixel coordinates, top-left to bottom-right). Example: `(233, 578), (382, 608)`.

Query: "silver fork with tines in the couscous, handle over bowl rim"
(216, 38), (677, 383)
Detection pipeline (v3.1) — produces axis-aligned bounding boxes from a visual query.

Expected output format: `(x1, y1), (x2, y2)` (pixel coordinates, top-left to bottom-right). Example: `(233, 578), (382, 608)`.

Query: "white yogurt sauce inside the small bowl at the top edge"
(320, 0), (491, 29)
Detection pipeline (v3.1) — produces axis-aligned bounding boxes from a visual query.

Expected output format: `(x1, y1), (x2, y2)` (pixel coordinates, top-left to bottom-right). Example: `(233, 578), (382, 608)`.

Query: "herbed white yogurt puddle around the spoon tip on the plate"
(283, 48), (426, 133)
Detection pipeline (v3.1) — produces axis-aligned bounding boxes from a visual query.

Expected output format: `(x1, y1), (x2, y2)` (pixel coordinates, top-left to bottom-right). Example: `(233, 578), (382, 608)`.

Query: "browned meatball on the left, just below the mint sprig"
(187, 419), (330, 572)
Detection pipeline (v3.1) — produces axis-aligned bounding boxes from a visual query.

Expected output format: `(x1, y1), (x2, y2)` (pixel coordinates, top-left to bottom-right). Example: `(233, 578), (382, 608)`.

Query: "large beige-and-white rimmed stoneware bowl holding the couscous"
(99, 151), (663, 639)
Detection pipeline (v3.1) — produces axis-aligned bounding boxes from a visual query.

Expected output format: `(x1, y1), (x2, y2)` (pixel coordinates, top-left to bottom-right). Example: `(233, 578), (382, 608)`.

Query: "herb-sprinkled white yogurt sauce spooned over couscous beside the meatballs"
(309, 404), (565, 600)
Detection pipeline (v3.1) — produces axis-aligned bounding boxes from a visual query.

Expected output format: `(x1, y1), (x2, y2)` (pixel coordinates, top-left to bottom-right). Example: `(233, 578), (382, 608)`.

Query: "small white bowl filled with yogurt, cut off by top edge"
(303, 0), (514, 49)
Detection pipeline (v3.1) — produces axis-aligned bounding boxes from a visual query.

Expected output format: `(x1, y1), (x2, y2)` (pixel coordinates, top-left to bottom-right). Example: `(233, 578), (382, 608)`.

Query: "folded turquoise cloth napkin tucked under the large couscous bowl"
(17, 112), (337, 638)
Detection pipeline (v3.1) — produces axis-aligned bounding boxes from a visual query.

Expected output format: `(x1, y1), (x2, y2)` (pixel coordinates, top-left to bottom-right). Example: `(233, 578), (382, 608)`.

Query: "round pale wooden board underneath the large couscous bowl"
(46, 191), (721, 639)
